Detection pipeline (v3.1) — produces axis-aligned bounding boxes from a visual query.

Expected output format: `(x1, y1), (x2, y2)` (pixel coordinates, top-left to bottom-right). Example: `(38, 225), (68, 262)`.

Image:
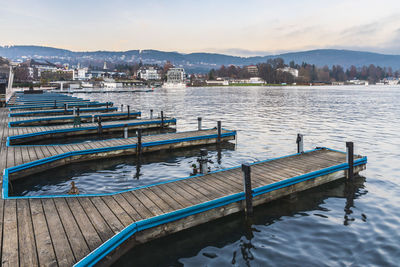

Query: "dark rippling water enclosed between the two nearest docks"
(10, 143), (235, 196)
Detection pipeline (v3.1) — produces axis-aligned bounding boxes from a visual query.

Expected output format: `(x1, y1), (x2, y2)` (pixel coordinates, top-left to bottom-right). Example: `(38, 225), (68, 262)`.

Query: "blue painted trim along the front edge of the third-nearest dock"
(7, 119), (176, 146)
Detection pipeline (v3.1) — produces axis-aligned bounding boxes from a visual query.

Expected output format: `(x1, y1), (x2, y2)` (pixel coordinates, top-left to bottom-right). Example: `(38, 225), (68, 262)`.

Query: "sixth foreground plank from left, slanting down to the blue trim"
(66, 198), (102, 250)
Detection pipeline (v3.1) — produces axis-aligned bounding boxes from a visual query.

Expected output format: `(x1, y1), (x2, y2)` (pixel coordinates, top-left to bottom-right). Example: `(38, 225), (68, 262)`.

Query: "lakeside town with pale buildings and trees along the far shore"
(0, 55), (400, 90)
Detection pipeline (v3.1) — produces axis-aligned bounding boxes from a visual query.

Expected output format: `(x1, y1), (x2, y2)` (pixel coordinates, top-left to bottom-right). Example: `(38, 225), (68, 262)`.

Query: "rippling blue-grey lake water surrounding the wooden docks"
(14, 86), (400, 267)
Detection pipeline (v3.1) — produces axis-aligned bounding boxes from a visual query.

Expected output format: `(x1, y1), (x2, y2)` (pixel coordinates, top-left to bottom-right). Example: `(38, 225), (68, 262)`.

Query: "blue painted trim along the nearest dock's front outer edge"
(74, 154), (367, 267)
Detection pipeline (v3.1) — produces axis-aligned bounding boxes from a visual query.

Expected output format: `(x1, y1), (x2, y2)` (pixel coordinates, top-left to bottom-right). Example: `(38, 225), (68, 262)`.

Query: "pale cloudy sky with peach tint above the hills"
(0, 0), (400, 56)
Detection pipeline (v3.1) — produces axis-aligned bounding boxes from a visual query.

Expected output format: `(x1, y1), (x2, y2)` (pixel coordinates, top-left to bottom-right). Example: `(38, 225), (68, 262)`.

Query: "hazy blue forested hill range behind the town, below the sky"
(0, 46), (400, 72)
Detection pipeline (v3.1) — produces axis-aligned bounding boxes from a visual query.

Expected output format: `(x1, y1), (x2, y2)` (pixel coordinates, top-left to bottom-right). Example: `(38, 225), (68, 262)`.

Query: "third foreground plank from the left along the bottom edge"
(29, 199), (57, 266)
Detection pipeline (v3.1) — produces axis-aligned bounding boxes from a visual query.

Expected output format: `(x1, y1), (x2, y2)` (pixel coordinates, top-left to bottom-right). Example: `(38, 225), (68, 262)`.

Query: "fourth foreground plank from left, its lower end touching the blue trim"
(42, 199), (76, 266)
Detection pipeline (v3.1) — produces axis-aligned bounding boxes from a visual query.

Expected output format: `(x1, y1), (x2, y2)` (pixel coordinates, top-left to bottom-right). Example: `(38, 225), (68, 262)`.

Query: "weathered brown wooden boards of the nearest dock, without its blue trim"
(0, 150), (361, 266)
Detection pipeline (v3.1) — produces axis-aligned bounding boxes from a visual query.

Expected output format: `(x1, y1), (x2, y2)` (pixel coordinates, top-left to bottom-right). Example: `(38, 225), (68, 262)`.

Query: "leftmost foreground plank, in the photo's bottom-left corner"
(1, 200), (19, 267)
